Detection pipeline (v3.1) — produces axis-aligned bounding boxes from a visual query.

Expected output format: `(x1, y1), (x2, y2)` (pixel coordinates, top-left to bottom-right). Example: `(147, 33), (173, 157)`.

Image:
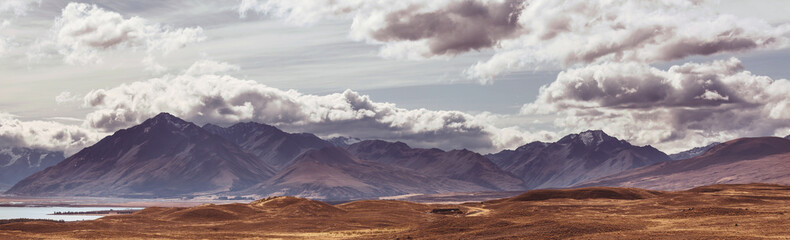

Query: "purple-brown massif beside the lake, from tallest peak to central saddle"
(7, 113), (524, 200)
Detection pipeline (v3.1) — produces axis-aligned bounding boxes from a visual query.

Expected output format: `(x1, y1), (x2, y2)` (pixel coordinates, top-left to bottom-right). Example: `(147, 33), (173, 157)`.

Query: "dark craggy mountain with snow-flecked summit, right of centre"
(488, 131), (670, 189)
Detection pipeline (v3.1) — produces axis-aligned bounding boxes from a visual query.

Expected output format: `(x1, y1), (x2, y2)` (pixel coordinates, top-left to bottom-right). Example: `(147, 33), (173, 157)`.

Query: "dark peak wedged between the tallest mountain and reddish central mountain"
(203, 122), (333, 170)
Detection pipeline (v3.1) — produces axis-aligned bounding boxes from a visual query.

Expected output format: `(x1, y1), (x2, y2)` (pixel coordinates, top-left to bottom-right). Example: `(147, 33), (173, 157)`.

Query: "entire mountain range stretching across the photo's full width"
(0, 113), (790, 200)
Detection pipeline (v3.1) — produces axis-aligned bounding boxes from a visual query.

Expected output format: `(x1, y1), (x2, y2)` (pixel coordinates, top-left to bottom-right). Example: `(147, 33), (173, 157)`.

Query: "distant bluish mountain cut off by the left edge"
(0, 147), (64, 191)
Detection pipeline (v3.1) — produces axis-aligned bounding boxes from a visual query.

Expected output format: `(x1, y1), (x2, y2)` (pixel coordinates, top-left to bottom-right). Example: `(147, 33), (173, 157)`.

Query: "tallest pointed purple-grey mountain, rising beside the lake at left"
(7, 113), (274, 197)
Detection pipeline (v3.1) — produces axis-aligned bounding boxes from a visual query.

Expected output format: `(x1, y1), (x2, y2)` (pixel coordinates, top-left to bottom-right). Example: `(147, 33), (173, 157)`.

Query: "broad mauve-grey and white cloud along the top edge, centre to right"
(239, 0), (790, 82)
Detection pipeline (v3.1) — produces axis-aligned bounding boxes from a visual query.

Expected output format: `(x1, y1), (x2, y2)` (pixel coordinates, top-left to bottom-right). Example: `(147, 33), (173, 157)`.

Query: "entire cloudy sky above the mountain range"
(0, 0), (790, 154)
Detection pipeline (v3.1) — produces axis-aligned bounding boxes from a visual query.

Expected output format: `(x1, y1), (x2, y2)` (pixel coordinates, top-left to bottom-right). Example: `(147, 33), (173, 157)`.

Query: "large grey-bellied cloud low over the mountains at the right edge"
(522, 58), (790, 150)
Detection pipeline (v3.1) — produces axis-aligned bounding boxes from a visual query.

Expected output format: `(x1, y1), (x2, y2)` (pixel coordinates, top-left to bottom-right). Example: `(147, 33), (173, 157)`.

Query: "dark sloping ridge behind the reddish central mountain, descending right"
(347, 140), (524, 191)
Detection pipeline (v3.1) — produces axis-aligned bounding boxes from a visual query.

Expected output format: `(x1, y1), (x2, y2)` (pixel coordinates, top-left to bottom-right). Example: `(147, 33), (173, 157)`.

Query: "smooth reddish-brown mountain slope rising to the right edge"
(577, 137), (790, 190)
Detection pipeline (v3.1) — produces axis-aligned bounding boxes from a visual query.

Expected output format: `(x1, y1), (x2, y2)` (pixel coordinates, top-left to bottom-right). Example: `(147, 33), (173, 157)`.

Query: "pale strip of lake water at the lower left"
(0, 207), (141, 221)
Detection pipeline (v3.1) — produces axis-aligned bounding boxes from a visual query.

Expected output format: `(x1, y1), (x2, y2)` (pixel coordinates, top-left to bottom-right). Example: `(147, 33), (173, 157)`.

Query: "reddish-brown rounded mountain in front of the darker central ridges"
(241, 147), (486, 200)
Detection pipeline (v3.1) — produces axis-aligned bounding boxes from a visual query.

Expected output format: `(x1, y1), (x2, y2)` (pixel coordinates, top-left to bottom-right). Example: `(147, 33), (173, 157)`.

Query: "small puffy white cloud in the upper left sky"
(31, 3), (206, 65)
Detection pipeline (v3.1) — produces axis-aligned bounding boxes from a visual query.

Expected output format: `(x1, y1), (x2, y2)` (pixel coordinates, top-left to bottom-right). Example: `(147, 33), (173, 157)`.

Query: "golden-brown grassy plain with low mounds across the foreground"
(0, 184), (790, 239)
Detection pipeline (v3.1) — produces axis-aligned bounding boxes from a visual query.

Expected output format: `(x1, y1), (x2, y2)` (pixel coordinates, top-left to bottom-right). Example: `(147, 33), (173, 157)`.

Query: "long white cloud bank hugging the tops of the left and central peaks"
(84, 61), (547, 151)
